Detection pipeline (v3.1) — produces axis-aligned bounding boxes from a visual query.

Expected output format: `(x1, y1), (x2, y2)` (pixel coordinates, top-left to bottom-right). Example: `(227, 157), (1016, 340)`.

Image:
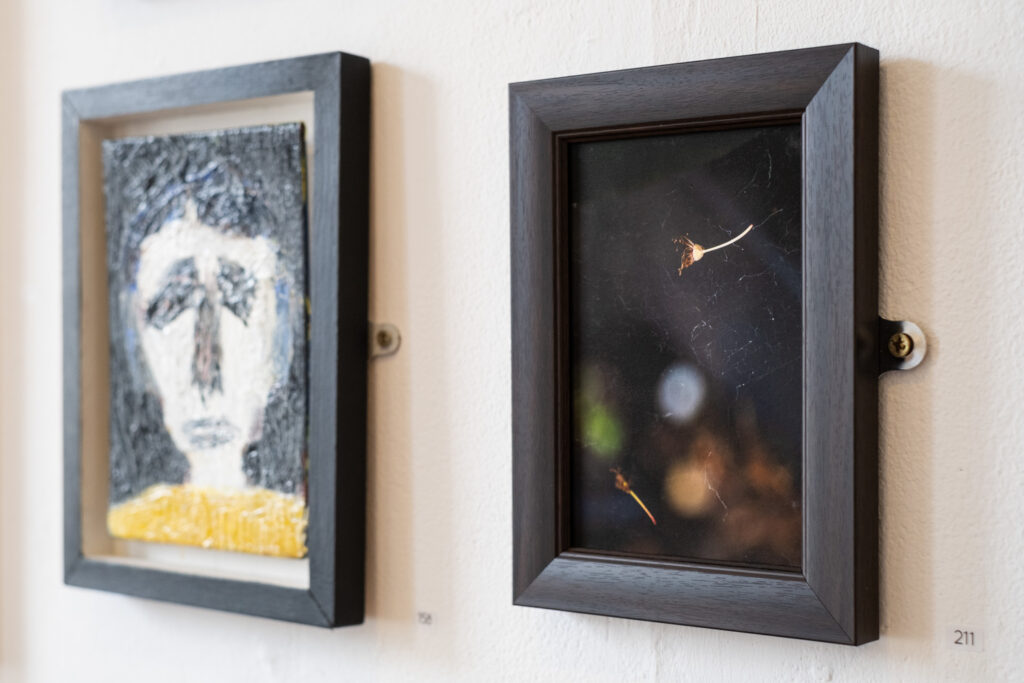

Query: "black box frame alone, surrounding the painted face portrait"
(62, 52), (370, 627)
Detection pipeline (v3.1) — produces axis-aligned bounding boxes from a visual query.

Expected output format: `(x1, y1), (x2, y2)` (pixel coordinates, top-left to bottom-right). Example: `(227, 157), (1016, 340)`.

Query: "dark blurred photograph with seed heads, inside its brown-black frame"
(568, 125), (802, 569)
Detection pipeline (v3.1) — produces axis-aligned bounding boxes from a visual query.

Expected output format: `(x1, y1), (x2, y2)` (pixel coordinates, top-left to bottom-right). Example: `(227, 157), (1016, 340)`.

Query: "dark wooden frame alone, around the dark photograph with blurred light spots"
(509, 43), (879, 644)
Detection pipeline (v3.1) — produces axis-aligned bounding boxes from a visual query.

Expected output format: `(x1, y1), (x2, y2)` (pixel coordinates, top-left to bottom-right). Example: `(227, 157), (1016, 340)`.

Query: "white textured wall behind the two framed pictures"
(0, 0), (1024, 683)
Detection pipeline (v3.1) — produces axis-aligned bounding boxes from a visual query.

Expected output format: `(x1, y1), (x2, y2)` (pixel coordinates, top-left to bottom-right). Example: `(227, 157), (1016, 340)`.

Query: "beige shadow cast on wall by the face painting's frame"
(367, 62), (456, 655)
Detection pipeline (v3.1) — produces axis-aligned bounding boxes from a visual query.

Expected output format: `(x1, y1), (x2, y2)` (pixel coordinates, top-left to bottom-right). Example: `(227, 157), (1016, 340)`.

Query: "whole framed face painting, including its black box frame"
(63, 53), (370, 627)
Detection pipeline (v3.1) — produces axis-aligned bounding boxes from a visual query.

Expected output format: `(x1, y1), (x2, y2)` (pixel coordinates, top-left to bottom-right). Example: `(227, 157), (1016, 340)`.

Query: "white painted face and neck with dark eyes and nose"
(135, 204), (291, 488)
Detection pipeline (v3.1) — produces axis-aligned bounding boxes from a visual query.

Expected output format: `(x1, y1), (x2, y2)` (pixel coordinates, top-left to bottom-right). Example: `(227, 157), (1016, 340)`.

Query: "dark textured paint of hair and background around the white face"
(103, 124), (307, 503)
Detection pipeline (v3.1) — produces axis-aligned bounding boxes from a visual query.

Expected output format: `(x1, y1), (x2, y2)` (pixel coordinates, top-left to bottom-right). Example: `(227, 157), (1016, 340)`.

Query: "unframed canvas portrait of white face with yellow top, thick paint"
(103, 124), (307, 557)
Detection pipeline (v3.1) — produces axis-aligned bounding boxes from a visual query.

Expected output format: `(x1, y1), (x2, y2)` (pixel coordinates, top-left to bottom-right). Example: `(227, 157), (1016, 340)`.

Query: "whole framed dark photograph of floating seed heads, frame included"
(509, 44), (882, 644)
